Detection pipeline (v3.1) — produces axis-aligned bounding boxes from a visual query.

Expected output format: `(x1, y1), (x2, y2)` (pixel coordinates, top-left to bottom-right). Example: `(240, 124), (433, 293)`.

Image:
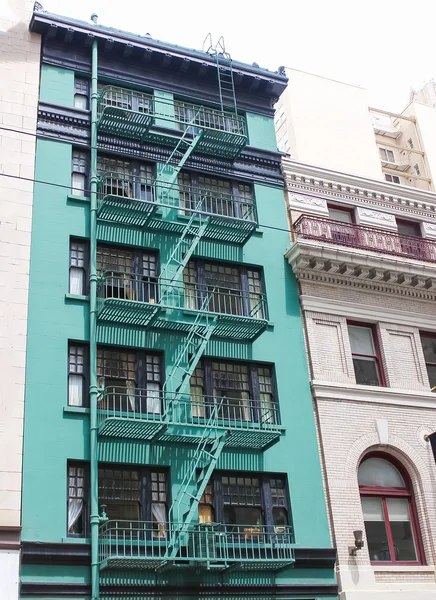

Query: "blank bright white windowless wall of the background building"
(276, 69), (384, 179)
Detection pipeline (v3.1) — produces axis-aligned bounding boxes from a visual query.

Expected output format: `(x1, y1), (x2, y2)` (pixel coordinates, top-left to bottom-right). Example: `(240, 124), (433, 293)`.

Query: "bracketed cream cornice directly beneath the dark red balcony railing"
(285, 239), (436, 300)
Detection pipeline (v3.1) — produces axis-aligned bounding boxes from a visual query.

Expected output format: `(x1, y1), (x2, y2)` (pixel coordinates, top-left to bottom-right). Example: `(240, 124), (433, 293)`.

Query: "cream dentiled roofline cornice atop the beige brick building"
(283, 159), (436, 221)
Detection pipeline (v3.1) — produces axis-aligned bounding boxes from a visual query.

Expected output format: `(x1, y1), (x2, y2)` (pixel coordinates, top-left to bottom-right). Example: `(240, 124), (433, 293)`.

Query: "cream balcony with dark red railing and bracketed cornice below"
(286, 215), (436, 300)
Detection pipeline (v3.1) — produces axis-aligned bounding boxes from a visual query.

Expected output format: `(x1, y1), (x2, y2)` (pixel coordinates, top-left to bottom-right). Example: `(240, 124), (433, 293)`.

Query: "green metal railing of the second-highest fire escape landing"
(98, 172), (257, 223)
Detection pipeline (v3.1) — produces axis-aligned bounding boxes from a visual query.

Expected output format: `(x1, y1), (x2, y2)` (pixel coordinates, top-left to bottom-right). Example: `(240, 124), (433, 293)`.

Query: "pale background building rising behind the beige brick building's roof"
(276, 69), (436, 191)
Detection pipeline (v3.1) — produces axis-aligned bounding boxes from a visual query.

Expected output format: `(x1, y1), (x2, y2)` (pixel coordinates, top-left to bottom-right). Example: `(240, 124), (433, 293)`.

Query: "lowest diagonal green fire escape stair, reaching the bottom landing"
(167, 404), (228, 559)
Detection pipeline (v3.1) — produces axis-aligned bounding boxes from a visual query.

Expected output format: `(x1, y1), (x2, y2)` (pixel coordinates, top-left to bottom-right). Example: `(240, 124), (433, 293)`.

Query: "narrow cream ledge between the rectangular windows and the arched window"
(311, 379), (436, 410)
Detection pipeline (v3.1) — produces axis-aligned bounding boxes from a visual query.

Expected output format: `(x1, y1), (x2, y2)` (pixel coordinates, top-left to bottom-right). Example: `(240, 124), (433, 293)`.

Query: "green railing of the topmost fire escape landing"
(98, 85), (247, 136)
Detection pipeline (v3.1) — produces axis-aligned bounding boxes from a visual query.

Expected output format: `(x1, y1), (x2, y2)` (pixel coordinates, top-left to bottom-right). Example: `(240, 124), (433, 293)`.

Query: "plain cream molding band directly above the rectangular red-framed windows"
(300, 293), (436, 331)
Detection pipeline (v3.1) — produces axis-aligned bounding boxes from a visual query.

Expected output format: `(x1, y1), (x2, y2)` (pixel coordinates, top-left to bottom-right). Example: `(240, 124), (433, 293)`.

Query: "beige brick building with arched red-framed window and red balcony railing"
(284, 156), (436, 600)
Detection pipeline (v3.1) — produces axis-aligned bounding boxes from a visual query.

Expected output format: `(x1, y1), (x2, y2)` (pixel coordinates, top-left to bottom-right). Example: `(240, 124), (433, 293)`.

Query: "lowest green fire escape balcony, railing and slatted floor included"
(99, 521), (295, 571)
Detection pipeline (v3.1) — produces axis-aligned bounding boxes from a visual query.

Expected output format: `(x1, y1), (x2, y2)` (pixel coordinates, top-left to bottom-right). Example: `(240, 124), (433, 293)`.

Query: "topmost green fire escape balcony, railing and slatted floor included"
(97, 86), (248, 159)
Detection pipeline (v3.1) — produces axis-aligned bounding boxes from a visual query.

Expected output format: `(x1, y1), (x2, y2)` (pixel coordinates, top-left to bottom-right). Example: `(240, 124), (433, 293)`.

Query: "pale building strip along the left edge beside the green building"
(0, 0), (40, 600)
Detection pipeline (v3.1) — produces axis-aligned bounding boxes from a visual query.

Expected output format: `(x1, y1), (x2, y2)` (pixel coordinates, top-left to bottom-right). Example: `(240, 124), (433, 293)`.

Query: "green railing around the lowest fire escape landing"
(99, 520), (294, 564)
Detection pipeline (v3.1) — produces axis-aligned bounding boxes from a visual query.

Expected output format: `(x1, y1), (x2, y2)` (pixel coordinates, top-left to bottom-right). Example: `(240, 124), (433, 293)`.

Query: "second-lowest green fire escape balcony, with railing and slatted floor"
(97, 387), (284, 450)
